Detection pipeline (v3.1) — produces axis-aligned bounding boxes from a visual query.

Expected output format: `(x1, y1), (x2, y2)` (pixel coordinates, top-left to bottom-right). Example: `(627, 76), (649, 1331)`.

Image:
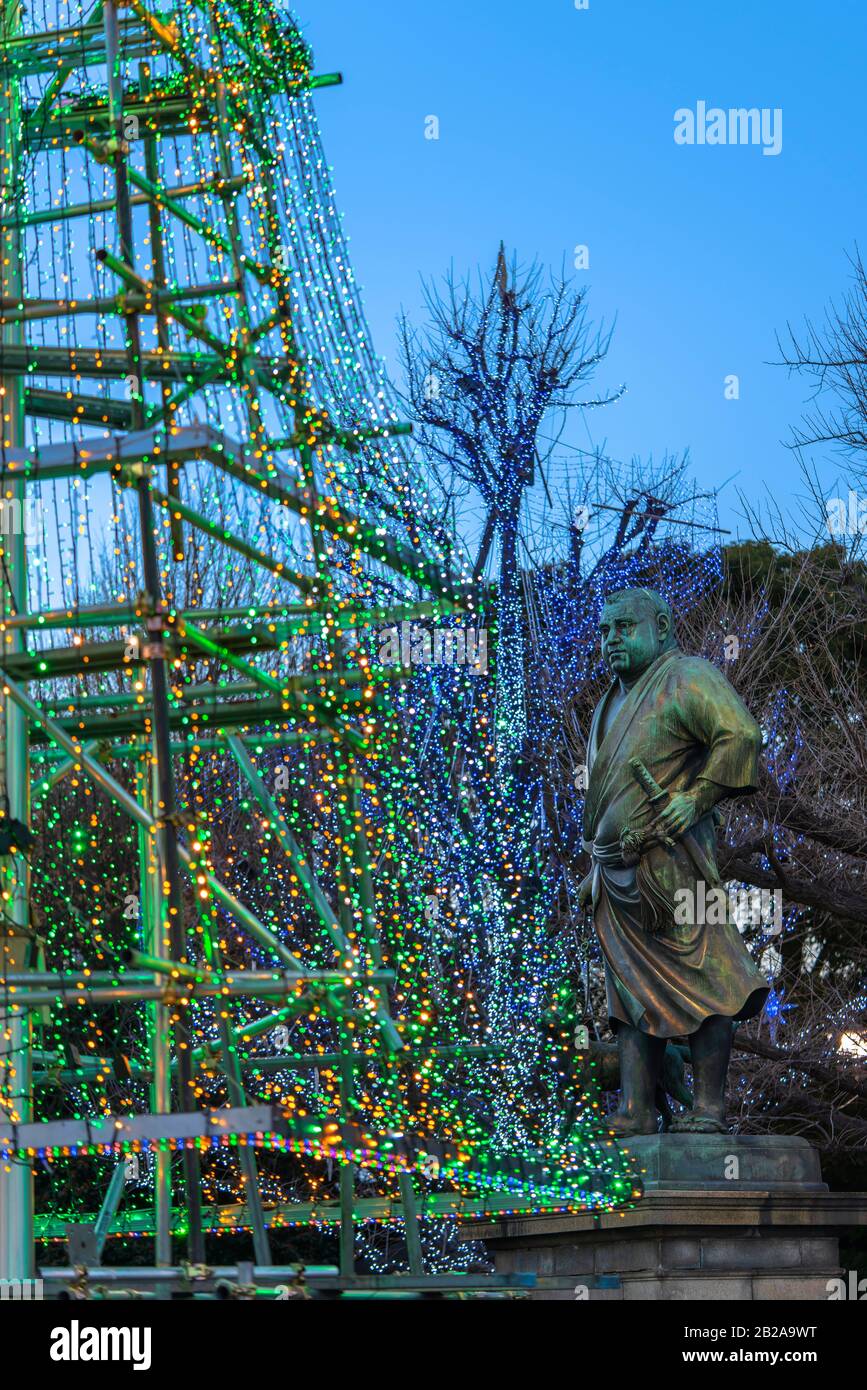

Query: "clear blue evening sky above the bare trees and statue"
(297, 0), (867, 530)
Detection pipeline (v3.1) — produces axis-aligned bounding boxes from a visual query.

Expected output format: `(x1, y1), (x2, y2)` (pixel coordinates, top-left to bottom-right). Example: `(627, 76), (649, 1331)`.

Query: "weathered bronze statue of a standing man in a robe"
(579, 589), (768, 1137)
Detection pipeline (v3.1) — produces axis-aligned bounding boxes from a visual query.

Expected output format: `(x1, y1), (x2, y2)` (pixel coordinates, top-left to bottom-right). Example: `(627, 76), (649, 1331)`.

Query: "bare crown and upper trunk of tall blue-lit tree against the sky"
(400, 246), (622, 608)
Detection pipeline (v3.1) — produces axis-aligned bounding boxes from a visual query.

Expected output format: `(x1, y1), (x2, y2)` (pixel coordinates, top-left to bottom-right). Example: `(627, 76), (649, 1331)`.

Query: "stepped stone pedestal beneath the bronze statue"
(461, 1134), (867, 1301)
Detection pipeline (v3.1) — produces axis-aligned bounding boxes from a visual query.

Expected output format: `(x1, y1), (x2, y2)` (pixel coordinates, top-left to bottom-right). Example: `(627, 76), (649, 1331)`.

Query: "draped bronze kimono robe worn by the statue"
(584, 649), (768, 1037)
